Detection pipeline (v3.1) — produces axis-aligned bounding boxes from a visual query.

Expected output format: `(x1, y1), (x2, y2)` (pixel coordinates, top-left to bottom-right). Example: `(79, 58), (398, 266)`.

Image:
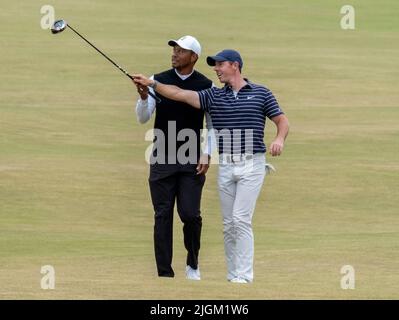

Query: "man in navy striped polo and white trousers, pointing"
(134, 49), (289, 283)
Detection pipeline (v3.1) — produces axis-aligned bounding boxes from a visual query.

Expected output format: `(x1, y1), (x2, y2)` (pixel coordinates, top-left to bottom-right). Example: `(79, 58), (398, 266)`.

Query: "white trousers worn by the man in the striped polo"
(218, 153), (266, 282)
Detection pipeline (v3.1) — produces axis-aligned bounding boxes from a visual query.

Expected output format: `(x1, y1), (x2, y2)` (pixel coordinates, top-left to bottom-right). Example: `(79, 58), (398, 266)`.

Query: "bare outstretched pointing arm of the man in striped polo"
(133, 74), (201, 109)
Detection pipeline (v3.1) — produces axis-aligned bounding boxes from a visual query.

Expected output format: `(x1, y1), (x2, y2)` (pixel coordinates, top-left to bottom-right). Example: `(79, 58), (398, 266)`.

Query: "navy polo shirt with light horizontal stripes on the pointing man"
(198, 79), (283, 154)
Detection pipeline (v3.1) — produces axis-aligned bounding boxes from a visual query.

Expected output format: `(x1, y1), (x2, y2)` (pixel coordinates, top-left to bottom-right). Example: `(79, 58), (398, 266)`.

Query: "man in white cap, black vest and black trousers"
(136, 36), (212, 280)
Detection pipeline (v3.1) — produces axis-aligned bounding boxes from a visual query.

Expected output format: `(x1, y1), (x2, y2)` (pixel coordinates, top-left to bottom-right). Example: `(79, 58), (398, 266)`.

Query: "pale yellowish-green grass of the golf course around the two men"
(0, 0), (399, 299)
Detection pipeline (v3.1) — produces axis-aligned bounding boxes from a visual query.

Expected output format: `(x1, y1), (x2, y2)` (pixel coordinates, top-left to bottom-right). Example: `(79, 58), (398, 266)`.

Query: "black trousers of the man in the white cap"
(149, 164), (205, 277)
